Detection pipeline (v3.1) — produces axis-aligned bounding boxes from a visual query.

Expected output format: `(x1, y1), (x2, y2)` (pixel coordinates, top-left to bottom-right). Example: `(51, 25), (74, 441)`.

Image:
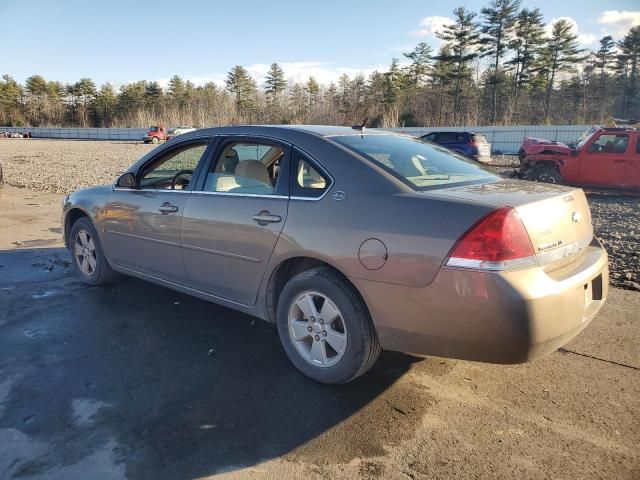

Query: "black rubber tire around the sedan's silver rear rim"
(277, 267), (380, 385)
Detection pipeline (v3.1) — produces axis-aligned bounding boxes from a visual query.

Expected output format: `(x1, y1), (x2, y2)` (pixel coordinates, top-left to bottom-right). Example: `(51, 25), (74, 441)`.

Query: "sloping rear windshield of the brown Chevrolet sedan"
(332, 135), (498, 190)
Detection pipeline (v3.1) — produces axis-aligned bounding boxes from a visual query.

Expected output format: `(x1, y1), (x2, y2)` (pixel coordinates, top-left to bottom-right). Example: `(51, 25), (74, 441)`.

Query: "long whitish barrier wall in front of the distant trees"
(0, 125), (589, 153)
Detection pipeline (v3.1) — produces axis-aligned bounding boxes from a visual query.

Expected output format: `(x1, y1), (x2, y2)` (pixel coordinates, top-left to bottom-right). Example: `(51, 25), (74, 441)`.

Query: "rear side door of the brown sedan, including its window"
(182, 137), (291, 305)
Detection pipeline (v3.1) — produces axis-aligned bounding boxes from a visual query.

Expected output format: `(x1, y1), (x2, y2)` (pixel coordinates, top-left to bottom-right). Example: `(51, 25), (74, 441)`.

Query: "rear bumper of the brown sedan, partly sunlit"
(352, 242), (609, 363)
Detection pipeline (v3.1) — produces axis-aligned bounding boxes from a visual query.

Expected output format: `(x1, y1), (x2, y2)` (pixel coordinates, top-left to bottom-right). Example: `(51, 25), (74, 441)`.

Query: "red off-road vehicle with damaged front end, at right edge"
(517, 127), (640, 190)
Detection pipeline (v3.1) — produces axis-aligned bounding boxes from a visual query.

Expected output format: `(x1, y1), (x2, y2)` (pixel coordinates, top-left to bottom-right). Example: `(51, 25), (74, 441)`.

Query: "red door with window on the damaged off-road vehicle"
(578, 132), (630, 186)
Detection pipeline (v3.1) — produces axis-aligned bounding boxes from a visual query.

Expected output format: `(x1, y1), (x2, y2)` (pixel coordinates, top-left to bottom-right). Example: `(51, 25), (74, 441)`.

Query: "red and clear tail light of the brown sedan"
(447, 207), (536, 270)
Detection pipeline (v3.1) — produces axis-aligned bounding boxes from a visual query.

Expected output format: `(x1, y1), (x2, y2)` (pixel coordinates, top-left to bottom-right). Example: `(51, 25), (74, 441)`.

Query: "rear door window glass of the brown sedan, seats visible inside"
(203, 142), (284, 195)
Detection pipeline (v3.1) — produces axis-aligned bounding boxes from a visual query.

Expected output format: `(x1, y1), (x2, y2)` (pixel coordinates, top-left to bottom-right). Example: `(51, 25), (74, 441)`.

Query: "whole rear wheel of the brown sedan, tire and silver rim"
(277, 267), (380, 384)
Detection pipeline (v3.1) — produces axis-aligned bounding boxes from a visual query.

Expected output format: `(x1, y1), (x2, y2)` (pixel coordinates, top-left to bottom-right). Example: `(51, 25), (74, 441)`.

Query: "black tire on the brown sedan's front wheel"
(68, 217), (118, 286)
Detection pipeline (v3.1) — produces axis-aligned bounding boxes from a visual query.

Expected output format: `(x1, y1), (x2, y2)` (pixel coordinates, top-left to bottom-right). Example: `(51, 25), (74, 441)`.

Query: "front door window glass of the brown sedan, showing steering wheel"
(140, 142), (207, 190)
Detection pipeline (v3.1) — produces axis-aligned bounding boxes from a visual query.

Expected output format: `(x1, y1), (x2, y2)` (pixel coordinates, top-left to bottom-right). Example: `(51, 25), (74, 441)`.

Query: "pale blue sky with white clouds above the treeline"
(0, 0), (640, 85)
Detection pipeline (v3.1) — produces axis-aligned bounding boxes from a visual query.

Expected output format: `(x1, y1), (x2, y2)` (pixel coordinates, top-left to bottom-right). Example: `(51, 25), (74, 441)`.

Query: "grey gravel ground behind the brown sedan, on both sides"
(0, 139), (640, 291)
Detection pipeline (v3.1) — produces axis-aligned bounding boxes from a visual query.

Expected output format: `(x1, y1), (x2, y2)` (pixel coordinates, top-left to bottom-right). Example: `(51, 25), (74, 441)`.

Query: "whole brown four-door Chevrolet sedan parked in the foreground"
(63, 126), (608, 384)
